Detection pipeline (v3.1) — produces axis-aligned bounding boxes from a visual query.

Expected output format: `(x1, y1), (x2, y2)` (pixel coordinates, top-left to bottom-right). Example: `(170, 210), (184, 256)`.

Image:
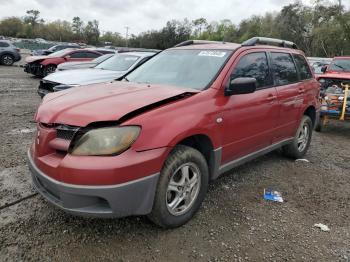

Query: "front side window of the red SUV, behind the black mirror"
(231, 52), (272, 88)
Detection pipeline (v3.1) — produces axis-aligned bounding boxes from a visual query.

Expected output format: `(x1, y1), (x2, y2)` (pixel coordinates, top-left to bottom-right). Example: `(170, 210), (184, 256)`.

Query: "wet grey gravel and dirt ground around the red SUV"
(0, 67), (350, 261)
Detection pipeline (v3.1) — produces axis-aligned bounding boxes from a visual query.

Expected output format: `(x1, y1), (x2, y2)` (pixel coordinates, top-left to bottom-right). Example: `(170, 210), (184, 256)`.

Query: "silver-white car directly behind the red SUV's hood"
(38, 52), (156, 97)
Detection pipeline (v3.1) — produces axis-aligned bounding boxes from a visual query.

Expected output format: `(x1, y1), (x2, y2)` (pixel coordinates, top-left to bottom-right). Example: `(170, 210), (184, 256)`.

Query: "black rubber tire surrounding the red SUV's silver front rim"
(148, 145), (209, 228)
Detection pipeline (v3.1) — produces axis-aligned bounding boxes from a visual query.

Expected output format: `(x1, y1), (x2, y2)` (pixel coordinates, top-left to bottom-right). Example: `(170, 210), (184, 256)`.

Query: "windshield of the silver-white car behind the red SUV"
(95, 55), (140, 71)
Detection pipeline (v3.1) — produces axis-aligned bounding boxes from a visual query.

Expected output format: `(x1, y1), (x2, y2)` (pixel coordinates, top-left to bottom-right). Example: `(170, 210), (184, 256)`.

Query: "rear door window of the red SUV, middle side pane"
(271, 53), (298, 86)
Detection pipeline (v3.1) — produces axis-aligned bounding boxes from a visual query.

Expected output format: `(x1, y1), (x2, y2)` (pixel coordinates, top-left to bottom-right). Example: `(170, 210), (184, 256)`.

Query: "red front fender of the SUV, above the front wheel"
(122, 89), (222, 151)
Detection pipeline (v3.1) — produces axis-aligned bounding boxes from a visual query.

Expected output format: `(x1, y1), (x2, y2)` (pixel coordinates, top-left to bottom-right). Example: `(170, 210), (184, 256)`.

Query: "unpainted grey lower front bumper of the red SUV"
(28, 151), (159, 217)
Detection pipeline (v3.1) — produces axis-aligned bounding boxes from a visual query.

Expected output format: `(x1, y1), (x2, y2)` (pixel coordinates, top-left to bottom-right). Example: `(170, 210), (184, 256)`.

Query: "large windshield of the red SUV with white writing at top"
(127, 50), (232, 90)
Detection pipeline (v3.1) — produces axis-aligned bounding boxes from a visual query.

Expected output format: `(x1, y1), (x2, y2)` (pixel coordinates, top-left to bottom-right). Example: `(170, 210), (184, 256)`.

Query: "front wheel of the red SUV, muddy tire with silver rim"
(148, 145), (209, 228)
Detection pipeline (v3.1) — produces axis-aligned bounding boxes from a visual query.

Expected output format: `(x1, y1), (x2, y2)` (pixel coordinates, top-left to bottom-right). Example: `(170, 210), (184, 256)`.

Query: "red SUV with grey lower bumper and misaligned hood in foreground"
(28, 38), (319, 227)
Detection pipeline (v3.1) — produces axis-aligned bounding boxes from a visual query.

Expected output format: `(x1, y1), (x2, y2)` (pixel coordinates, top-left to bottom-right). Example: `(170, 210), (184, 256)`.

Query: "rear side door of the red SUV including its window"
(270, 52), (305, 142)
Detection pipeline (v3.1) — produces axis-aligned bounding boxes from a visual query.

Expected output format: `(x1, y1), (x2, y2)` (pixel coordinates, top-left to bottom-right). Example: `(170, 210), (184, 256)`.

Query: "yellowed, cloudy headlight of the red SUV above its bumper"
(71, 126), (141, 156)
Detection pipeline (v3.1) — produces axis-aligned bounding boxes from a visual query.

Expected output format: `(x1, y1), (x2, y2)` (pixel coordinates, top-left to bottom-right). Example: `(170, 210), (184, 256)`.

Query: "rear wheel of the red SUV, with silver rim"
(282, 115), (313, 159)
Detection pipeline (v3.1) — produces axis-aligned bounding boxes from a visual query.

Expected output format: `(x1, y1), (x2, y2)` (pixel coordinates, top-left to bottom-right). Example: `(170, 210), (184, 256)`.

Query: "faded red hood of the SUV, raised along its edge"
(35, 82), (199, 126)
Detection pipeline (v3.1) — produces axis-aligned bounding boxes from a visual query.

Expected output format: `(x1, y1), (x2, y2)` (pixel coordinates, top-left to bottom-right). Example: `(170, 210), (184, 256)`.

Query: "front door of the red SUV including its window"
(222, 51), (279, 163)
